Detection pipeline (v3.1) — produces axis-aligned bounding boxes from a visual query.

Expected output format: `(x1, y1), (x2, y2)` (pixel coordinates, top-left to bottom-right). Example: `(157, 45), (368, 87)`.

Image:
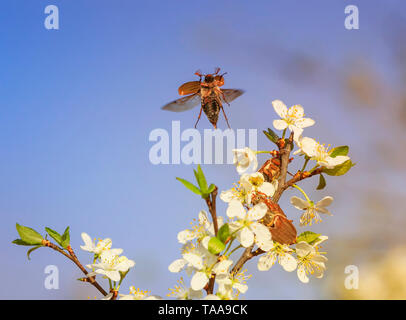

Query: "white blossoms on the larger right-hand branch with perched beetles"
(169, 100), (350, 299)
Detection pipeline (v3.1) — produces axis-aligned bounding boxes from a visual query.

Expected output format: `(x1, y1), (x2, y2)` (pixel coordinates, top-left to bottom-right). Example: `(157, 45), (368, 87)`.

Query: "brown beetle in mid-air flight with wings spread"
(162, 68), (244, 129)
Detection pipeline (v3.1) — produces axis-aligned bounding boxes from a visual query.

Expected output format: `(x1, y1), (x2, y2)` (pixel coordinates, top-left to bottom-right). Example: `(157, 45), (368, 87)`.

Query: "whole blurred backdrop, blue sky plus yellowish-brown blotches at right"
(0, 0), (406, 299)
